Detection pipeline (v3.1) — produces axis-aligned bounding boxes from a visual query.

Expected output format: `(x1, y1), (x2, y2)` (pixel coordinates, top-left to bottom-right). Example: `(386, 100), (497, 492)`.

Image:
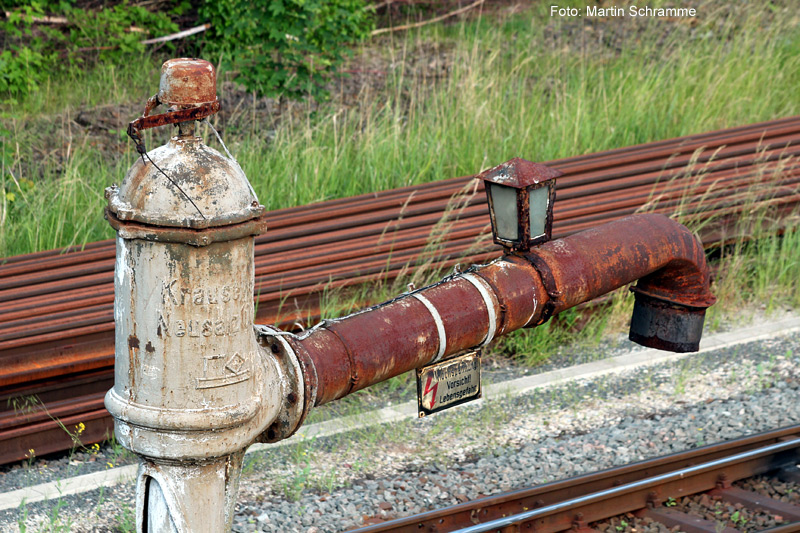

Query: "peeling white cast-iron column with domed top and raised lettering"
(106, 120), (296, 533)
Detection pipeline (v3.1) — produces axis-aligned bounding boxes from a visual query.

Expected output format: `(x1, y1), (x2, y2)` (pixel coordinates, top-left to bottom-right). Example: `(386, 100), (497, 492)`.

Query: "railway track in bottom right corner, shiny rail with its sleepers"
(357, 426), (800, 533)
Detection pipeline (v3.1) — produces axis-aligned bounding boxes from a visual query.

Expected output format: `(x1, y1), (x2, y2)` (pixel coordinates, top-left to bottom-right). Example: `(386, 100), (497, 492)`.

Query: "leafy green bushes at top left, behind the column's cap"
(0, 0), (372, 103)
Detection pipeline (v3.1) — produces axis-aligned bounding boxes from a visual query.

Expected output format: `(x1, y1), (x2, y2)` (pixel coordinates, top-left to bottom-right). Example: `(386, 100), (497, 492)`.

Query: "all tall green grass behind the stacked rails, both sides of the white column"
(0, 3), (800, 256)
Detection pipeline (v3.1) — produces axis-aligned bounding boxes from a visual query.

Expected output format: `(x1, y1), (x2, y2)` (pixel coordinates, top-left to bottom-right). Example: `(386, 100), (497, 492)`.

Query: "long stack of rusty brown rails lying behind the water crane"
(0, 116), (800, 463)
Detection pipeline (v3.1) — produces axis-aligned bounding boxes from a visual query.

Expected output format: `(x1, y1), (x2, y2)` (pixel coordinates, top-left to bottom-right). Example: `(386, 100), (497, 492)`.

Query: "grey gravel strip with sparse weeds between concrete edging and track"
(0, 322), (800, 533)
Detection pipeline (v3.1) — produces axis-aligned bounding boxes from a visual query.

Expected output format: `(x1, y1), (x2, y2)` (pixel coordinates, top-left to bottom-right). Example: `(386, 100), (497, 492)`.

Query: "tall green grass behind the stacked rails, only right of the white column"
(239, 1), (800, 207)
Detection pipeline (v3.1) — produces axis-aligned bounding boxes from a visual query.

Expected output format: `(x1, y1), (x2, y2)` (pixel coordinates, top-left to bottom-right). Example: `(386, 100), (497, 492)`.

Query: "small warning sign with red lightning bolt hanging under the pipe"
(417, 352), (481, 417)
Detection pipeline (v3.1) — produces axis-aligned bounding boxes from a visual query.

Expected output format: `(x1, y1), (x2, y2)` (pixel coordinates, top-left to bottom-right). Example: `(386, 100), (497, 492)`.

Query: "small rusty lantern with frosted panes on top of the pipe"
(478, 157), (562, 252)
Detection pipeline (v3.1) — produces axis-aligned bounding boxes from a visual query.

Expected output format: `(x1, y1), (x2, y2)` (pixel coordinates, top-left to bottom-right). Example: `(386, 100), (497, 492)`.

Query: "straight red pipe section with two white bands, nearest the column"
(293, 260), (547, 405)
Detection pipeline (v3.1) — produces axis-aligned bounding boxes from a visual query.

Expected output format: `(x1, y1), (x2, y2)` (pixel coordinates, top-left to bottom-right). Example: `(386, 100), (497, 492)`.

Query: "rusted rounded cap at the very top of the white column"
(158, 57), (217, 107)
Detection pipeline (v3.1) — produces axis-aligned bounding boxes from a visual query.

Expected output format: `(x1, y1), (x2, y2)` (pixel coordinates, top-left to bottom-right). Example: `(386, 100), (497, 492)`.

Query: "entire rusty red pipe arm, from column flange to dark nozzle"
(291, 214), (714, 405)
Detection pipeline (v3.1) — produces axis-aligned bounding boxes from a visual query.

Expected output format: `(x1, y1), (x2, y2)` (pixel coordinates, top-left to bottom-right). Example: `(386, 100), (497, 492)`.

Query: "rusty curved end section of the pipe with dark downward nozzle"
(526, 214), (716, 352)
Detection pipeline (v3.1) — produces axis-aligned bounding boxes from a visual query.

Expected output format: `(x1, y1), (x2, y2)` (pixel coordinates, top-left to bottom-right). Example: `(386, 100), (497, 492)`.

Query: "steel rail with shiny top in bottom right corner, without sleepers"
(356, 426), (800, 533)
